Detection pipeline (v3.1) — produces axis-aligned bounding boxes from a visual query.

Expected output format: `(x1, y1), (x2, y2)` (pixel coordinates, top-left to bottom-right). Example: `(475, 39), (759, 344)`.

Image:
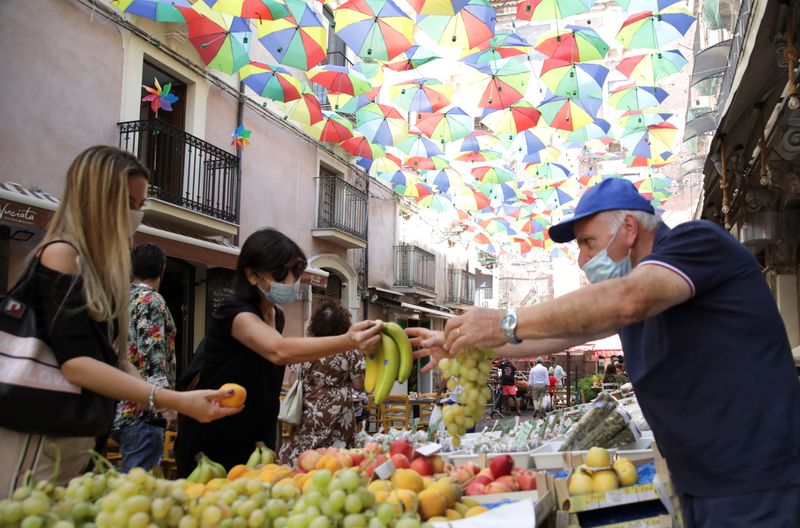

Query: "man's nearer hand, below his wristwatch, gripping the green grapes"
(444, 308), (507, 355)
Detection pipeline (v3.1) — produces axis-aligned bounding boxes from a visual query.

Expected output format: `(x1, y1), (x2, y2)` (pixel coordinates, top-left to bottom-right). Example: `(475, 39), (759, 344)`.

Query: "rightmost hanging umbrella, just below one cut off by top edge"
(617, 9), (694, 49)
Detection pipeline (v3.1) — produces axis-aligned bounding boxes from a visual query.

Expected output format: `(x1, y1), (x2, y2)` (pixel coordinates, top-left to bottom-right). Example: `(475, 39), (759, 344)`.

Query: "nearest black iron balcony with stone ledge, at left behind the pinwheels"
(117, 119), (240, 236)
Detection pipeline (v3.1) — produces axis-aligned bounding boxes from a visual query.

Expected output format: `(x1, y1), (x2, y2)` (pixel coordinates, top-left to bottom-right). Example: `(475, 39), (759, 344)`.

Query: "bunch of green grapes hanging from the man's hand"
(439, 348), (496, 447)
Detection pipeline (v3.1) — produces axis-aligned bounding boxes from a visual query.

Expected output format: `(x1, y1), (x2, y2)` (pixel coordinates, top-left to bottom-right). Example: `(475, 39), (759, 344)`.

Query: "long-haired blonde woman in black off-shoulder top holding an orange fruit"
(0, 146), (241, 499)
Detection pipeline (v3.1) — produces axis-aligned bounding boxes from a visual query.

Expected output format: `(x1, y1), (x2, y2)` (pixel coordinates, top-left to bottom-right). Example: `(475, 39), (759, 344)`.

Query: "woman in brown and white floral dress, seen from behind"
(279, 301), (364, 463)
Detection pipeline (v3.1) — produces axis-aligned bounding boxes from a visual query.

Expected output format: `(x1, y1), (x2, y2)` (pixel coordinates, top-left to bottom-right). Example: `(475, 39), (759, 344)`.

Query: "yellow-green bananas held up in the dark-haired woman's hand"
(364, 321), (414, 405)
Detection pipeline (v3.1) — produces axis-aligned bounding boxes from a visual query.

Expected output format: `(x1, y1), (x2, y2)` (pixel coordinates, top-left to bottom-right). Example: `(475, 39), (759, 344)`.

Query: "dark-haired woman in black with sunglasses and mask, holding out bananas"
(175, 229), (381, 476)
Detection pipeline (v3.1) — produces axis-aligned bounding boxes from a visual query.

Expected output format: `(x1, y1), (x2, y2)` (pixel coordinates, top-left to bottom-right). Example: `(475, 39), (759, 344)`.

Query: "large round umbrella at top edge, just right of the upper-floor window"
(335, 0), (414, 60)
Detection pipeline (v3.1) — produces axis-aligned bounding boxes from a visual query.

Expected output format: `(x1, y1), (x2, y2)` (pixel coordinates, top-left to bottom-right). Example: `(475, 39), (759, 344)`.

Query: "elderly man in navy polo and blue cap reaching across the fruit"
(409, 178), (800, 527)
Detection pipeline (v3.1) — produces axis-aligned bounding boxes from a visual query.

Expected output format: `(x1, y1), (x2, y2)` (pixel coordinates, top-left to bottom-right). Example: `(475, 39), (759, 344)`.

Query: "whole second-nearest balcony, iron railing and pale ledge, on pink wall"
(311, 176), (367, 249)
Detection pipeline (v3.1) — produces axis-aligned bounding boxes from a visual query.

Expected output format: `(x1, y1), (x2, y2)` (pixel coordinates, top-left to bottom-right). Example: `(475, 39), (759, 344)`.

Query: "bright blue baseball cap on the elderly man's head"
(549, 178), (656, 242)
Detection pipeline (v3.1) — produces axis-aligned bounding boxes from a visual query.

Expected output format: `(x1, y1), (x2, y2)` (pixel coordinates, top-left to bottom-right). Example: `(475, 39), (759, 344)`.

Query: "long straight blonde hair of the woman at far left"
(40, 145), (150, 358)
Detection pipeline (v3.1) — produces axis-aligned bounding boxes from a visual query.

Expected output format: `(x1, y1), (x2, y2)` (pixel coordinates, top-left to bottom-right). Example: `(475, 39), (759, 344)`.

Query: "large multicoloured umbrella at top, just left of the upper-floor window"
(256, 0), (328, 70)
